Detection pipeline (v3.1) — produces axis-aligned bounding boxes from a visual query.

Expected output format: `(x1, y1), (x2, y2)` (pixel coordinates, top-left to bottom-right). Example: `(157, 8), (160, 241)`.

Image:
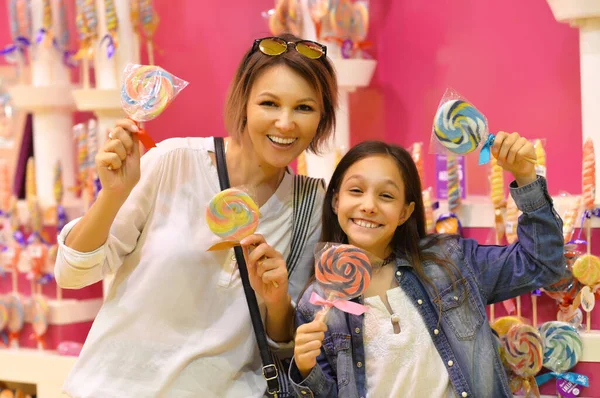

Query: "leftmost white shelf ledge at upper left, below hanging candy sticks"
(8, 85), (75, 112)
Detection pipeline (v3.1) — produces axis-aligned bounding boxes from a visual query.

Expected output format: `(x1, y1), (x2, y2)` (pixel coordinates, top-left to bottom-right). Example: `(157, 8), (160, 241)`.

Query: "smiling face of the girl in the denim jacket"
(333, 155), (415, 259)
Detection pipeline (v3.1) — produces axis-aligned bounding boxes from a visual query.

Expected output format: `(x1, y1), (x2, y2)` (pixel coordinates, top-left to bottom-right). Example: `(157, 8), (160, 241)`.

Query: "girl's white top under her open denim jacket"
(364, 286), (456, 398)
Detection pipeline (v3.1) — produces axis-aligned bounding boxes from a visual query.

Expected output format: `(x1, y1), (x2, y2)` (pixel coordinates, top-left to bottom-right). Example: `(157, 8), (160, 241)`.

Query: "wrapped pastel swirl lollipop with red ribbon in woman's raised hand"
(121, 64), (188, 149)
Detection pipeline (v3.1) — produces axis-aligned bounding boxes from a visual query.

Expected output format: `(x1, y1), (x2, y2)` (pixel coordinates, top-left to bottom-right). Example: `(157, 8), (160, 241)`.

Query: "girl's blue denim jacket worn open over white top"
(289, 177), (566, 398)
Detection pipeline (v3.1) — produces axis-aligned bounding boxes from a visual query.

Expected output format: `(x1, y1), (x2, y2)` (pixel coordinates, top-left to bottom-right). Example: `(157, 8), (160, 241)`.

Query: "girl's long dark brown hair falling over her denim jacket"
(300, 141), (459, 304)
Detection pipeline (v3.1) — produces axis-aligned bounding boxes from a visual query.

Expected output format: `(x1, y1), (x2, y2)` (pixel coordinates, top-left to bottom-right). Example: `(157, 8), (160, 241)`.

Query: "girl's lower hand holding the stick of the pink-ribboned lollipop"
(294, 312), (327, 378)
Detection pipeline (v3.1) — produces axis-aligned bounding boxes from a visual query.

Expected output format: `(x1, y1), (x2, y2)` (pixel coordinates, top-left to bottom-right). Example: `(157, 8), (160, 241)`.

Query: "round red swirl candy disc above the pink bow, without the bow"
(315, 245), (372, 299)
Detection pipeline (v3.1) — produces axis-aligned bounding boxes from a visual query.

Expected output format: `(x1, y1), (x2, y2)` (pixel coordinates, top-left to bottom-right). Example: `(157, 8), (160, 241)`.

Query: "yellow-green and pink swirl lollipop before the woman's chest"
(206, 188), (260, 251)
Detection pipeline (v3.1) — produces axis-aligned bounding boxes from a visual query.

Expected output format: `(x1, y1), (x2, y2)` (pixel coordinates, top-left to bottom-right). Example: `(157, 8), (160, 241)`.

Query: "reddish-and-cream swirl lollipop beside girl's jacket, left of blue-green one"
(502, 324), (544, 397)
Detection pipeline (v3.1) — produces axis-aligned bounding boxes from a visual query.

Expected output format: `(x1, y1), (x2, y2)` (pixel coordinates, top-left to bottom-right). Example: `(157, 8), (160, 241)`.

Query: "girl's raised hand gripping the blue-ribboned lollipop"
(492, 131), (537, 186)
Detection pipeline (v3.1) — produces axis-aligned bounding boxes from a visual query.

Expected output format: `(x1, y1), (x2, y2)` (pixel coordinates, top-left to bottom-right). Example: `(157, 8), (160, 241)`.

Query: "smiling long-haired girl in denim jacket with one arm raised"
(290, 133), (565, 398)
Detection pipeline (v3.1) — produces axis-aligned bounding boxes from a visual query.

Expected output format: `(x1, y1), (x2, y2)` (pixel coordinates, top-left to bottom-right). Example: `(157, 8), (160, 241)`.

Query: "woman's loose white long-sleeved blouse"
(55, 138), (324, 398)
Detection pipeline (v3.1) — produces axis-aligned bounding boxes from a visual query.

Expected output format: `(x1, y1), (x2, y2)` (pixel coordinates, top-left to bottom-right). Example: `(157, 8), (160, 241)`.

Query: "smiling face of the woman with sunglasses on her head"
(246, 65), (321, 168)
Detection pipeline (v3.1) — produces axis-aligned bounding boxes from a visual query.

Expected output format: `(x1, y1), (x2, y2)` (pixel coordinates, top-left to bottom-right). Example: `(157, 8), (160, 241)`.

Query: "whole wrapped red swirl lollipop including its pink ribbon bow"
(310, 243), (373, 315)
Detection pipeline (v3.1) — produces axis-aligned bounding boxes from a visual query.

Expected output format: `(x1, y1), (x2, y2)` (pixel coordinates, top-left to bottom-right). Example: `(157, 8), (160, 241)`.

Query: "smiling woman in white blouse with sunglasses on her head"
(55, 35), (337, 398)
